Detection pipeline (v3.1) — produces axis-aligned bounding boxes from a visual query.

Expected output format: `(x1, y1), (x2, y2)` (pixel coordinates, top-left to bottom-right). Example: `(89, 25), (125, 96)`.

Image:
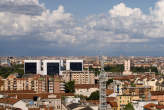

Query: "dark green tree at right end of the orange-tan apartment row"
(65, 81), (75, 93)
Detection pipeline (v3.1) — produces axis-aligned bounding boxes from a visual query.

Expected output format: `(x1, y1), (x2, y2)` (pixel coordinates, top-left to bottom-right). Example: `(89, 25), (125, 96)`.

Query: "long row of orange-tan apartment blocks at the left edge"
(0, 75), (64, 93)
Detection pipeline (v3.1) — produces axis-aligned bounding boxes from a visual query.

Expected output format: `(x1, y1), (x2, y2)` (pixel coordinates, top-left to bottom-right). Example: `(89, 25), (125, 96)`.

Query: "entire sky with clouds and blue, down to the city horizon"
(0, 0), (164, 56)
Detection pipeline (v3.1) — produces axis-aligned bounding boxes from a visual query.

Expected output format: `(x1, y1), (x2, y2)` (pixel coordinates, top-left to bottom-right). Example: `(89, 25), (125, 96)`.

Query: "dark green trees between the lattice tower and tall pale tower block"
(104, 65), (124, 72)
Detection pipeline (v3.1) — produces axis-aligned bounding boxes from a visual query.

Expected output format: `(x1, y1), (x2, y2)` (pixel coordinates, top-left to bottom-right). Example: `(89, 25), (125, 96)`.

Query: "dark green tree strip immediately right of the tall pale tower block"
(131, 67), (158, 73)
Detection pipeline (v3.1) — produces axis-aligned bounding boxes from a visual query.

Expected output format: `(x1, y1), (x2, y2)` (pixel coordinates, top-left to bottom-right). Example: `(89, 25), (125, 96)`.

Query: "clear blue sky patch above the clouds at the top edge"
(40, 0), (157, 17)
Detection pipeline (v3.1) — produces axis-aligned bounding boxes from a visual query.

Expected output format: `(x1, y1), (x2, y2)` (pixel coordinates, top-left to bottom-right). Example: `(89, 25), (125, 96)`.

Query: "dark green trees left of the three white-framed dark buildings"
(0, 64), (24, 78)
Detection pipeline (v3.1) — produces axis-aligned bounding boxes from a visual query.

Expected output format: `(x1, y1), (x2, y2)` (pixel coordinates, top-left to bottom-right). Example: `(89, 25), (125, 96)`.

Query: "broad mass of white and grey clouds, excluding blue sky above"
(0, 0), (164, 55)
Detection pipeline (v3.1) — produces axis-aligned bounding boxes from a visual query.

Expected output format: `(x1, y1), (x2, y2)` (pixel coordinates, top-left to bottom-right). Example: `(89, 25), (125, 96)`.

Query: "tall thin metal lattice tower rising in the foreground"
(99, 56), (107, 110)
